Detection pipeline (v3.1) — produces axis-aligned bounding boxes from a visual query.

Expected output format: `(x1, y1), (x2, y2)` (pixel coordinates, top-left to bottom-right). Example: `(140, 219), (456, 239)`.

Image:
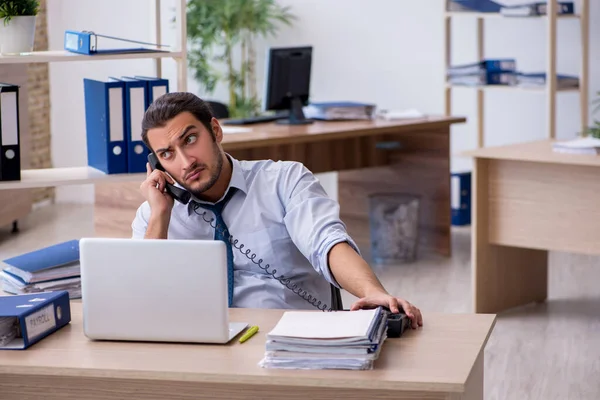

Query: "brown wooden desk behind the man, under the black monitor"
(95, 117), (466, 255)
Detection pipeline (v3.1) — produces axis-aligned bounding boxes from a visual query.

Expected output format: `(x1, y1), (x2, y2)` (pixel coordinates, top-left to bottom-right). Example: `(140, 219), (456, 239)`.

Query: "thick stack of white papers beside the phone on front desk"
(259, 307), (387, 370)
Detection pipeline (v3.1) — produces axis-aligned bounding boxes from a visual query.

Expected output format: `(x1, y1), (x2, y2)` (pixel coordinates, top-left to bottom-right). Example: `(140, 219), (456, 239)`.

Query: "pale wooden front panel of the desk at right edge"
(488, 160), (600, 254)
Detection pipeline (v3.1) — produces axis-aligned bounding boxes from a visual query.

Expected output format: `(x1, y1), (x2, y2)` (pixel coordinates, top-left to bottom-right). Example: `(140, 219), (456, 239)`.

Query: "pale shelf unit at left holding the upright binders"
(0, 0), (187, 190)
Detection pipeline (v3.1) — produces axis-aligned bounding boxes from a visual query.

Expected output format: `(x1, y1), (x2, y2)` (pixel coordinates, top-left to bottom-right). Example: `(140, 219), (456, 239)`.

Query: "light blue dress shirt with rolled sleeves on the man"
(132, 155), (360, 309)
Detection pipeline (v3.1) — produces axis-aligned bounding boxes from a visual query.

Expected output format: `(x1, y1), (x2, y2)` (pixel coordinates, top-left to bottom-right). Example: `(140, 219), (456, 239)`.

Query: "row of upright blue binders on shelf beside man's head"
(83, 76), (169, 174)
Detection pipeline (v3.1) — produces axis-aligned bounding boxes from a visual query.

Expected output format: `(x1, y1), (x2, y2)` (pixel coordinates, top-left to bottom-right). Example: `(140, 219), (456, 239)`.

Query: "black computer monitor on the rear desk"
(265, 46), (312, 125)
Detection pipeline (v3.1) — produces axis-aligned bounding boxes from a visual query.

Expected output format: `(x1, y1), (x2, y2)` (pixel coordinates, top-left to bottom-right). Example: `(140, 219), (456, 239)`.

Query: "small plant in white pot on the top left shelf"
(0, 0), (40, 54)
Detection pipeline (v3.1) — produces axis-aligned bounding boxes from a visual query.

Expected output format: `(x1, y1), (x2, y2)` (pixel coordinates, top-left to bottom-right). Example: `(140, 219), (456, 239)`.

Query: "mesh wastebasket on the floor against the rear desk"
(369, 193), (420, 263)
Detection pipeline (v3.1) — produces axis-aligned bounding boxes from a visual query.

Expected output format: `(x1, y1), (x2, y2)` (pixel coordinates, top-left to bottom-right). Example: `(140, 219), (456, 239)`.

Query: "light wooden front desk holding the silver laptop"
(0, 302), (496, 400)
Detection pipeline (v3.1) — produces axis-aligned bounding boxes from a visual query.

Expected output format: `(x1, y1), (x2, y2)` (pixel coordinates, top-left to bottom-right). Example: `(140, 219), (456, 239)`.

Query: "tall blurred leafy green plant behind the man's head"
(187, 0), (295, 118)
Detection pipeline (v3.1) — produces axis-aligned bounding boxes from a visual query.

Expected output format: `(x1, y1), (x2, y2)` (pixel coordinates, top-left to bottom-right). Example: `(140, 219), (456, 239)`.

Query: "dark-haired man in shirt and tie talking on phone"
(132, 93), (423, 328)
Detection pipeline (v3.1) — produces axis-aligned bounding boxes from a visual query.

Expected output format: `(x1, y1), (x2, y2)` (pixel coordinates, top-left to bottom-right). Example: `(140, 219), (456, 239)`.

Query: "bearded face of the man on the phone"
(148, 112), (223, 197)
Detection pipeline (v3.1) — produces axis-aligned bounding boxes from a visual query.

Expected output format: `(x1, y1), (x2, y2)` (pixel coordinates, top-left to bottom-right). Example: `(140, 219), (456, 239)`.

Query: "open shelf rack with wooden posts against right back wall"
(444, 0), (590, 148)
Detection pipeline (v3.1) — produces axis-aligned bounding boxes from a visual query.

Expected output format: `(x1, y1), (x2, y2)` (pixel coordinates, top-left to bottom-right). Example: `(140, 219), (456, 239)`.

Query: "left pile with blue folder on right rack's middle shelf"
(448, 58), (518, 86)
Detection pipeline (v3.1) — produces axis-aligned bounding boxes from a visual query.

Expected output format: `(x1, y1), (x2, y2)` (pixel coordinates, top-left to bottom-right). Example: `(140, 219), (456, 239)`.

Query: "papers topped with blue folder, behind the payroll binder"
(0, 240), (81, 298)
